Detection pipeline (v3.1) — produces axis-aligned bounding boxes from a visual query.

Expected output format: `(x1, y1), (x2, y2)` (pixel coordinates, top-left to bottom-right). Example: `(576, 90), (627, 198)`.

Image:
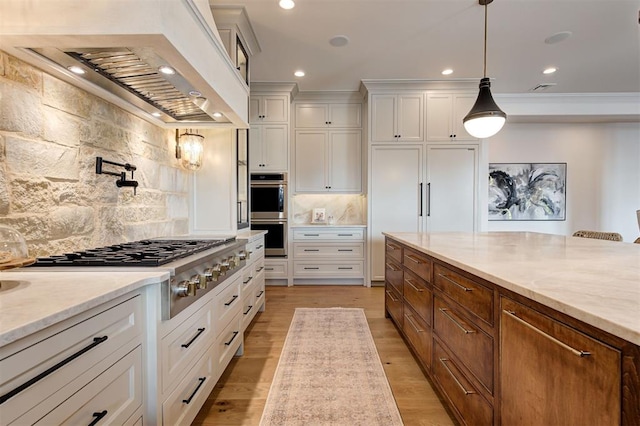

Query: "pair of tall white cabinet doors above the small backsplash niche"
(295, 130), (362, 192)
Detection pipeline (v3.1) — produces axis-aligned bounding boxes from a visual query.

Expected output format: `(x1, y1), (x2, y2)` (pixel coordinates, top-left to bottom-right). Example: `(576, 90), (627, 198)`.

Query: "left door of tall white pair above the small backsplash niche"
(295, 131), (328, 192)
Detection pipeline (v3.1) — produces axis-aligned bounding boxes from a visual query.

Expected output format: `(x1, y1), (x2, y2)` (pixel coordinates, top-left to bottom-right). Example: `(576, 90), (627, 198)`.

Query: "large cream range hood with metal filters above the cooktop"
(0, 0), (249, 128)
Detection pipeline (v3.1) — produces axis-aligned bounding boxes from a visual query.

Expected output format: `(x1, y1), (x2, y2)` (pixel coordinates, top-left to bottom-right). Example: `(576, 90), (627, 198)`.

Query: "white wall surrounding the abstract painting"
(486, 123), (640, 242)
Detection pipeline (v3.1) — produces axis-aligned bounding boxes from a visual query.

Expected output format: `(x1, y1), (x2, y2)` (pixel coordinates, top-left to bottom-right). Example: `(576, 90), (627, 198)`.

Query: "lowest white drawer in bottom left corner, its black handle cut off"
(35, 346), (142, 425)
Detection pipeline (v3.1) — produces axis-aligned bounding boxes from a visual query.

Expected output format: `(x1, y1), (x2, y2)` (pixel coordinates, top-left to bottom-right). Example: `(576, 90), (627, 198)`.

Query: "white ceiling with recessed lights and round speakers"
(210, 0), (640, 93)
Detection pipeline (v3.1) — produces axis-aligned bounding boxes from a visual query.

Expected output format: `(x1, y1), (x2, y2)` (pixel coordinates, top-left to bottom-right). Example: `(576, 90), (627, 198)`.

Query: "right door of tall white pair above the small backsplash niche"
(329, 130), (362, 192)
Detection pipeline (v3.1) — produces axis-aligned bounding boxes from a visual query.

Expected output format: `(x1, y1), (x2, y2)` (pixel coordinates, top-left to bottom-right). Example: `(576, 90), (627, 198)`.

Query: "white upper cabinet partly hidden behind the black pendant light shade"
(427, 92), (478, 142)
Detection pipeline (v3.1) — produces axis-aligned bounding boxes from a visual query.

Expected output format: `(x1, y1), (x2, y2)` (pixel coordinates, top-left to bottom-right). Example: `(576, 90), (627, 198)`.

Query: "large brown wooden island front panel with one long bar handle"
(500, 298), (621, 425)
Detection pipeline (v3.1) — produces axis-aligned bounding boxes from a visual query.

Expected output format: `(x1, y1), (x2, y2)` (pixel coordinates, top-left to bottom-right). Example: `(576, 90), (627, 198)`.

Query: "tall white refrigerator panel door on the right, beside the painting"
(427, 146), (478, 232)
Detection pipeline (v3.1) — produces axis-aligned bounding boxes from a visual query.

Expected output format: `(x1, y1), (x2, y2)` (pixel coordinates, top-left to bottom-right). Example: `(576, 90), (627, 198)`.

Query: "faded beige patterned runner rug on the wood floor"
(260, 308), (402, 426)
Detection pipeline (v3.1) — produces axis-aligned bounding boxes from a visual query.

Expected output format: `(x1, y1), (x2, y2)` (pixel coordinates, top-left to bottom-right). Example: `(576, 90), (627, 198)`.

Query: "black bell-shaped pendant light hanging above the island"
(462, 0), (507, 139)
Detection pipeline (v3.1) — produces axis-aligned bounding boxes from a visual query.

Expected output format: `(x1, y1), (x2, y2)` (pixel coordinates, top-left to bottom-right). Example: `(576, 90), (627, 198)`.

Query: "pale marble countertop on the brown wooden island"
(384, 232), (640, 345)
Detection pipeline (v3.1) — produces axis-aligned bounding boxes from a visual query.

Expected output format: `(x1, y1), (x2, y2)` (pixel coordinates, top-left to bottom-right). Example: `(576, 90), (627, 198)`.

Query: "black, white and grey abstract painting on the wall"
(489, 163), (567, 220)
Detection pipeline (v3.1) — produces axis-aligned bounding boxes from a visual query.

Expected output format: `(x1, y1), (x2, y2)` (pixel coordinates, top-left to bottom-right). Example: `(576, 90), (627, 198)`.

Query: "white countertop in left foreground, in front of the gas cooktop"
(0, 270), (169, 347)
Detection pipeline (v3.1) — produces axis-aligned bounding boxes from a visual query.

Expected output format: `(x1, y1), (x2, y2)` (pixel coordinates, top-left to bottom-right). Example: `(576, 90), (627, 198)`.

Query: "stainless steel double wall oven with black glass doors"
(251, 173), (288, 257)
